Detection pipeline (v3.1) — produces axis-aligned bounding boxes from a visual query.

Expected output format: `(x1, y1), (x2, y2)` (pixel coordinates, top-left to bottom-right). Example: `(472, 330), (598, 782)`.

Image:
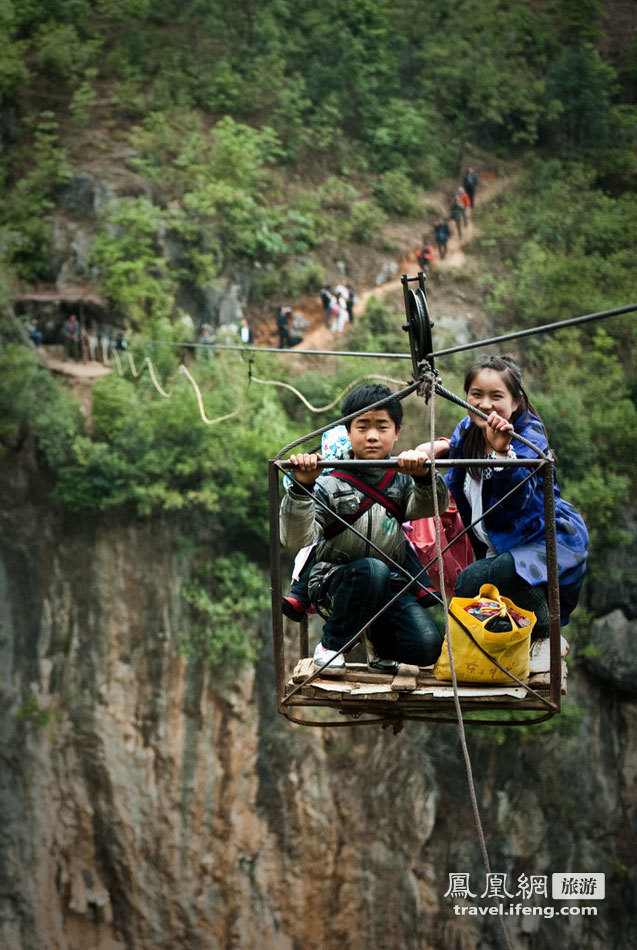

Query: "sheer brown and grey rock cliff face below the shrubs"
(0, 457), (637, 950)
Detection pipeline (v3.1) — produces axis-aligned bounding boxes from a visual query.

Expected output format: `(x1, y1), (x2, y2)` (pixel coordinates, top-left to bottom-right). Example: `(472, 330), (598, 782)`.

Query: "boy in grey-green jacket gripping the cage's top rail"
(281, 384), (449, 669)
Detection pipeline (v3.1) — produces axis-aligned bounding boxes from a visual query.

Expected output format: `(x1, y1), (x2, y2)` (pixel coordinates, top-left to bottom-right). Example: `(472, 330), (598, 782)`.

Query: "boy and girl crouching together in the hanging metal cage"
(280, 356), (588, 670)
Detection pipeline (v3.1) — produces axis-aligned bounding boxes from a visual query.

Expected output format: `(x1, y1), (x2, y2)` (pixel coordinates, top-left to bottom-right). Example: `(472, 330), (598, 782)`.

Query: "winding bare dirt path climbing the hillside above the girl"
(294, 173), (517, 350)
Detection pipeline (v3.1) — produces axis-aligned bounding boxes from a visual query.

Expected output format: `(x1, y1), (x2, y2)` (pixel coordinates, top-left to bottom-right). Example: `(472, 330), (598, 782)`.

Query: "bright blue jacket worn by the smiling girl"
(446, 413), (588, 624)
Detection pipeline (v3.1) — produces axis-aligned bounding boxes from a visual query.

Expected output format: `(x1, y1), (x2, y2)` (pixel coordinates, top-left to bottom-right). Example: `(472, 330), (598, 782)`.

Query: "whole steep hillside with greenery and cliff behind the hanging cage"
(0, 0), (637, 950)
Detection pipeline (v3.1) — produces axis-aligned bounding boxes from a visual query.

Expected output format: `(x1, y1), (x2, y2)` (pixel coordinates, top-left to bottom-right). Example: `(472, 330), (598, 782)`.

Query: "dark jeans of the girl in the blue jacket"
(454, 551), (549, 640)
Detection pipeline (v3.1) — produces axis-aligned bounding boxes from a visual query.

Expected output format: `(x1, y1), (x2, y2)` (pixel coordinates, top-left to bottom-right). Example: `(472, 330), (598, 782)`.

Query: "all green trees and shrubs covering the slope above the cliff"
(0, 0), (637, 665)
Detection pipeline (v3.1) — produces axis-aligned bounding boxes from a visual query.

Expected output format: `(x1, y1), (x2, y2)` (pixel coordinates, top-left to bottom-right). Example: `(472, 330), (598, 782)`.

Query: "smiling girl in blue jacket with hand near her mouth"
(419, 356), (588, 639)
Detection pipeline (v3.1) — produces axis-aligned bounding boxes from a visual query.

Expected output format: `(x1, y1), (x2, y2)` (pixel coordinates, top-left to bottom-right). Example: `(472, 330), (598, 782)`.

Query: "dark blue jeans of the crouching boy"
(316, 557), (443, 666)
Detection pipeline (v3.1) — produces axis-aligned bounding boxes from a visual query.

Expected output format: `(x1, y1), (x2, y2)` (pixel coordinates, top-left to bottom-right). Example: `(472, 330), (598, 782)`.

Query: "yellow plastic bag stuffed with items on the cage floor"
(434, 584), (536, 683)
